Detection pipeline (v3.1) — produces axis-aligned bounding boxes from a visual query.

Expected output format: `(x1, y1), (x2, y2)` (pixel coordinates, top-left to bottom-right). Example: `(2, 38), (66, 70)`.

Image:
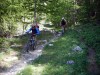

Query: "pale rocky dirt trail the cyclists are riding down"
(0, 30), (58, 75)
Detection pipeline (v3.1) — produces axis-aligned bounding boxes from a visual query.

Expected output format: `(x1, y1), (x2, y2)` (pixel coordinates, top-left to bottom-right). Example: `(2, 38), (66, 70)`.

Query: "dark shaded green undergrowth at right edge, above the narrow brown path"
(77, 23), (100, 68)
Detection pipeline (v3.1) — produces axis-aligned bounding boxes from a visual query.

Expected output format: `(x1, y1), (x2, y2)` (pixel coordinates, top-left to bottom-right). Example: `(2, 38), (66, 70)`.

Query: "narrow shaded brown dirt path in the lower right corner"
(88, 48), (100, 75)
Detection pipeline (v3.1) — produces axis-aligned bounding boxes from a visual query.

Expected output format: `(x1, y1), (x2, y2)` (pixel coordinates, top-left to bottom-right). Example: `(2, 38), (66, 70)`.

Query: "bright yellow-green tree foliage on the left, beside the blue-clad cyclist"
(0, 0), (31, 36)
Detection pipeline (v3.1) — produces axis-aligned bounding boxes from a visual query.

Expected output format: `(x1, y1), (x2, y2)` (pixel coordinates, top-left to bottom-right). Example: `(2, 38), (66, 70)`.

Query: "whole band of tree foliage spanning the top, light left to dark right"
(0, 0), (100, 35)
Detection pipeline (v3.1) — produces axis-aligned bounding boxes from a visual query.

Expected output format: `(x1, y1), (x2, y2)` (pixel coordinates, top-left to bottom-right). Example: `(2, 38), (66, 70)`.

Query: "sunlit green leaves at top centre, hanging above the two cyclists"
(36, 0), (79, 26)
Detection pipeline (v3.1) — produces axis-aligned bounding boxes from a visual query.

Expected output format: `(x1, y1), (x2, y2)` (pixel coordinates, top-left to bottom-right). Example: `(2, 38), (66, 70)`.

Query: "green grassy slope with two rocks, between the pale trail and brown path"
(18, 30), (87, 75)
